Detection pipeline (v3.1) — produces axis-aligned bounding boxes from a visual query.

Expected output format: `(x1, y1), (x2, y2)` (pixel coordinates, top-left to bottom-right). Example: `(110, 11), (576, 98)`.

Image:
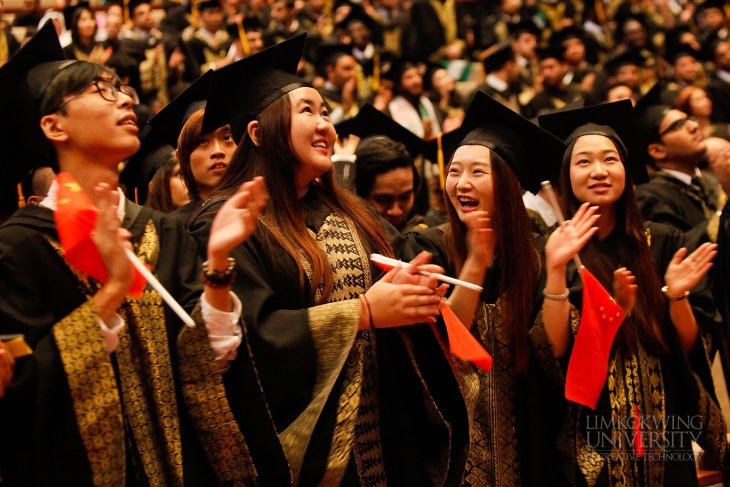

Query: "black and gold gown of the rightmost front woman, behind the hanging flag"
(530, 222), (726, 487)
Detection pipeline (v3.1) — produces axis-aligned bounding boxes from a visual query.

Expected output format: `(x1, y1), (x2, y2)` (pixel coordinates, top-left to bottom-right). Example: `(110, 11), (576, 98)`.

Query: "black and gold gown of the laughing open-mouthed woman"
(403, 226), (566, 487)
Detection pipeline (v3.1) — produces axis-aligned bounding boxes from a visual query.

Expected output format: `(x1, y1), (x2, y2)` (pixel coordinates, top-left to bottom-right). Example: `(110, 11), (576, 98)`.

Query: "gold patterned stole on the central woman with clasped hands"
(279, 213), (386, 486)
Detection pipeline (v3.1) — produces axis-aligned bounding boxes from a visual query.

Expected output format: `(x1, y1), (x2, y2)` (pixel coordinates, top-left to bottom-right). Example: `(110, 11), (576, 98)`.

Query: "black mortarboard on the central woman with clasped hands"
(203, 34), (309, 143)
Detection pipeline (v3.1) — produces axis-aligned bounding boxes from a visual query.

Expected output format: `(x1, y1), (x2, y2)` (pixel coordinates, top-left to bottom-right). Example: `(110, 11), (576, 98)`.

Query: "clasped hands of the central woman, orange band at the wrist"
(365, 268), (441, 328)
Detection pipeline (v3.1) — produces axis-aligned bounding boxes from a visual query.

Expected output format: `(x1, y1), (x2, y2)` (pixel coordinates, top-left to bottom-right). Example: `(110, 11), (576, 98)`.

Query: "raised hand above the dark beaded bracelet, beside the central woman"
(208, 177), (269, 270)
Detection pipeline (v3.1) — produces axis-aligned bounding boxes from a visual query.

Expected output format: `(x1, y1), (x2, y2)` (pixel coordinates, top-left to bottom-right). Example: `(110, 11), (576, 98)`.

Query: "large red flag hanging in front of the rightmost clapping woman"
(565, 268), (622, 409)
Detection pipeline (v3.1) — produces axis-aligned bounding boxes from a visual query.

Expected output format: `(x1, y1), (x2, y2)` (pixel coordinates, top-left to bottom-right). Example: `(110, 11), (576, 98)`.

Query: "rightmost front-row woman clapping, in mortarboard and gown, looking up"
(531, 100), (726, 486)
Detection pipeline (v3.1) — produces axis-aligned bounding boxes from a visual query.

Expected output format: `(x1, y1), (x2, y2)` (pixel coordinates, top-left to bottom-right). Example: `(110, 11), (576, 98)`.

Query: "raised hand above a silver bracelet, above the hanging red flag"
(545, 203), (600, 268)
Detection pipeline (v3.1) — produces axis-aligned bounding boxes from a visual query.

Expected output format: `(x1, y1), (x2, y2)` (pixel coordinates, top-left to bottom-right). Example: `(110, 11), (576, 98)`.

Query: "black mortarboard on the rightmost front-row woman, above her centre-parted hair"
(538, 100), (649, 184)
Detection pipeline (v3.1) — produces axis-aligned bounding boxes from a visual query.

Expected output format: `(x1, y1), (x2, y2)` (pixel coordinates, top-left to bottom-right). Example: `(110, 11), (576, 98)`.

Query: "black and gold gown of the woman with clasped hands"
(191, 191), (466, 487)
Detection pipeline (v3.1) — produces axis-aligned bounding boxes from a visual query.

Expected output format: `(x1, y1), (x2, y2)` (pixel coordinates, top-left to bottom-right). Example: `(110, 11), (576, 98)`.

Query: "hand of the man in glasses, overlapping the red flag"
(91, 183), (134, 295)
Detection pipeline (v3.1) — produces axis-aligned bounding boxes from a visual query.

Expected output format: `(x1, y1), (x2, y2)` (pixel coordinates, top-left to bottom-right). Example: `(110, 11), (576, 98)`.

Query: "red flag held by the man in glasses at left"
(53, 173), (147, 298)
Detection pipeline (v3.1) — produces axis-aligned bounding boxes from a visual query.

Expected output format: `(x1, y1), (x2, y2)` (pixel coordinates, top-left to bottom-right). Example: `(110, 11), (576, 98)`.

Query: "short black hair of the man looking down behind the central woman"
(355, 135), (421, 198)
